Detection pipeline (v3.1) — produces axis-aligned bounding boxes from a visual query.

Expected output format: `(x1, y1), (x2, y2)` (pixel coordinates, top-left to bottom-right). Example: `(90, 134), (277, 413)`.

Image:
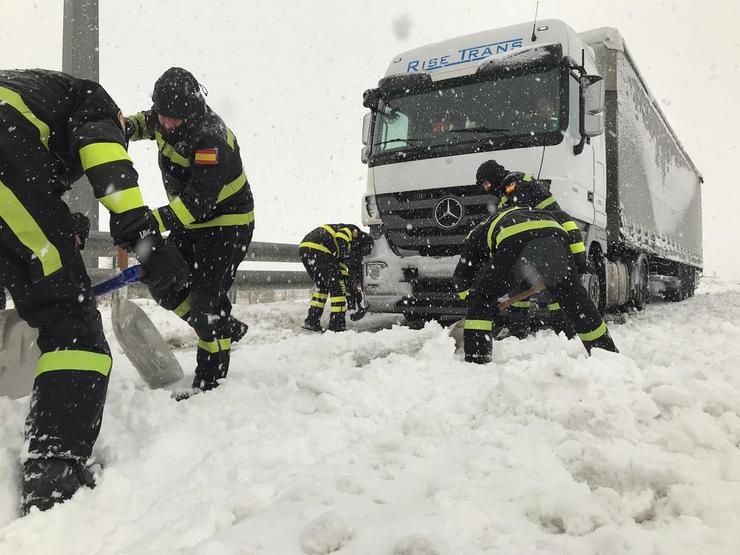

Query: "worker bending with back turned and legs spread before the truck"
(455, 206), (617, 364)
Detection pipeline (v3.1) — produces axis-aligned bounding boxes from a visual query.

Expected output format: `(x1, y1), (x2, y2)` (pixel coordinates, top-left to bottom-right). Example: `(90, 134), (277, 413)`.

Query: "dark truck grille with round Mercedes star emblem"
(375, 185), (495, 256)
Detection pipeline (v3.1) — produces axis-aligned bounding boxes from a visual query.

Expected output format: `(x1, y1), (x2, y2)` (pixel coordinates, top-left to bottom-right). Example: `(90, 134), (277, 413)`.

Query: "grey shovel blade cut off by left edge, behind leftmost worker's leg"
(0, 310), (41, 399)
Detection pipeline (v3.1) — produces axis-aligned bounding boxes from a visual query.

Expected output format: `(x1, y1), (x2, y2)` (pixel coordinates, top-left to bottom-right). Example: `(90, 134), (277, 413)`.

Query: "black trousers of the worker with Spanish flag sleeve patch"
(149, 225), (254, 389)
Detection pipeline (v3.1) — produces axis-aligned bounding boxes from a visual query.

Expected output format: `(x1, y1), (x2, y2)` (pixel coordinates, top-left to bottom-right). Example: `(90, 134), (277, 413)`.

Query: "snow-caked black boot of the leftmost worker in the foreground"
(21, 459), (95, 516)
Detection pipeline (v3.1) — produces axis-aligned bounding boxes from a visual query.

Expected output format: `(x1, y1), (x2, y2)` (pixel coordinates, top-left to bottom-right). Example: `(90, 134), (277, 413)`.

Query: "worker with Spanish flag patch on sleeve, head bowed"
(126, 67), (254, 399)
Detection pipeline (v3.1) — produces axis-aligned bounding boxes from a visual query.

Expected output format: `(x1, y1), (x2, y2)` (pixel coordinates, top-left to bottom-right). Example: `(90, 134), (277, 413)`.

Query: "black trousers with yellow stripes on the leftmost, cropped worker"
(0, 168), (112, 461)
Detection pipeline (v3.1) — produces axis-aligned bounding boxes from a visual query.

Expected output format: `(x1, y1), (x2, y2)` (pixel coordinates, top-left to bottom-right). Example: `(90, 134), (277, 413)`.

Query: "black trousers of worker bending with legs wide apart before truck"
(463, 234), (616, 362)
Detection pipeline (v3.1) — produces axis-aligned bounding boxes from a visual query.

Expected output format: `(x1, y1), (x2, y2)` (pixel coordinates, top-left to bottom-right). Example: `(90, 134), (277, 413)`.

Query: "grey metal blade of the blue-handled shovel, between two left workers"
(112, 297), (185, 388)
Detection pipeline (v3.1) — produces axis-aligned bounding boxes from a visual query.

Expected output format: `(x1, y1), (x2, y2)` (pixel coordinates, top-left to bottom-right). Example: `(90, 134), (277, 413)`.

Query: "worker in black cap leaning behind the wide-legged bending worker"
(462, 160), (588, 339)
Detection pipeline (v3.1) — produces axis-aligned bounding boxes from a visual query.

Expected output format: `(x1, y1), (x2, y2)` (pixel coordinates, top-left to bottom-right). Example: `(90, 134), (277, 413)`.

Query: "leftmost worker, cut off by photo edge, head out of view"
(0, 70), (187, 514)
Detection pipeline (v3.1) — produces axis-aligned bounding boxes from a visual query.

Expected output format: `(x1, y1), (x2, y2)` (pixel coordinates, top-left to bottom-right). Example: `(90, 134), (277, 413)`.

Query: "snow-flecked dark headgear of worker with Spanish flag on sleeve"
(152, 67), (206, 120)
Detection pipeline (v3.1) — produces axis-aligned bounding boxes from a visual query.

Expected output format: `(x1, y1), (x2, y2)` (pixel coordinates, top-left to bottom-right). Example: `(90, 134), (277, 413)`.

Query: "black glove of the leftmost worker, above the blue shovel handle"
(133, 232), (189, 291)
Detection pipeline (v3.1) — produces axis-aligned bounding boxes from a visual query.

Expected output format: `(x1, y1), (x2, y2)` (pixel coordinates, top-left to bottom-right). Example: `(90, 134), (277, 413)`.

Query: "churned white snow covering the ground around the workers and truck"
(0, 280), (740, 555)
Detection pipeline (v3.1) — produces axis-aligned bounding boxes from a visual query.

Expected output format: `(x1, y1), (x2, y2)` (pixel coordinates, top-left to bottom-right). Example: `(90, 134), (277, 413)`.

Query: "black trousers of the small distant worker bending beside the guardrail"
(298, 247), (347, 331)
